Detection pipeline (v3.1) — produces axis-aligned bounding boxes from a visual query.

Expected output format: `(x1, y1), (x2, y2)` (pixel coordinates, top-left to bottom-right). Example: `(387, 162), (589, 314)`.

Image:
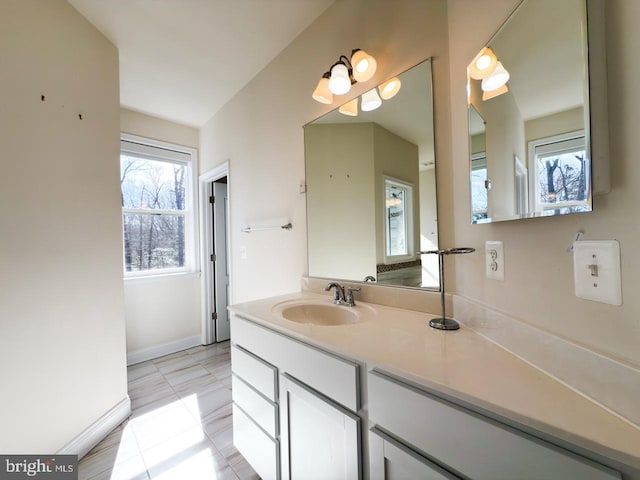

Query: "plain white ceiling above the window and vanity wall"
(68, 0), (334, 127)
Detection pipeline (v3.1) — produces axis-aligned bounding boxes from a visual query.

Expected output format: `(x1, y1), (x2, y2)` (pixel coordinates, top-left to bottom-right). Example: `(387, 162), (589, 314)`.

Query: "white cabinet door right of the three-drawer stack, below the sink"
(280, 375), (362, 480)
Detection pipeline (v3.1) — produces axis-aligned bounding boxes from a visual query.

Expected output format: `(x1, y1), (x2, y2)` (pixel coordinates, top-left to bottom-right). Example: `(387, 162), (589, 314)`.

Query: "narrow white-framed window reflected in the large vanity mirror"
(384, 178), (413, 262)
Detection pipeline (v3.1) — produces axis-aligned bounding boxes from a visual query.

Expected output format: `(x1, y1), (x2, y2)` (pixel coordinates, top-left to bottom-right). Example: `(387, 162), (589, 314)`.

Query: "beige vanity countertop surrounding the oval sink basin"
(229, 292), (640, 469)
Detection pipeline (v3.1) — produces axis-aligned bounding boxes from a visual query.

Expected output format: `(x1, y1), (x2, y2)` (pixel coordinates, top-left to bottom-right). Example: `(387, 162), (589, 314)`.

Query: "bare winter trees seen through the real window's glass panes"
(120, 153), (188, 272)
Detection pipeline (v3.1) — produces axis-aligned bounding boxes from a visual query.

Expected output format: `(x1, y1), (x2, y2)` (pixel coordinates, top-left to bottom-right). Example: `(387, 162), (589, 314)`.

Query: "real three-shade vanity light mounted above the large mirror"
(311, 48), (377, 105)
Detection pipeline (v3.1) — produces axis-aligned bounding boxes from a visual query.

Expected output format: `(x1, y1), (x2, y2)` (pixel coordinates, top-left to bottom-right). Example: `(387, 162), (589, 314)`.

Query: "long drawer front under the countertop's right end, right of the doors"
(368, 371), (621, 480)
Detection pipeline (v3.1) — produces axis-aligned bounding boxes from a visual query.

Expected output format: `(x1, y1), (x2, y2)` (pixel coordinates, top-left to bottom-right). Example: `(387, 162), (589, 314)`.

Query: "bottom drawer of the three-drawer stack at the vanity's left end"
(233, 405), (280, 480)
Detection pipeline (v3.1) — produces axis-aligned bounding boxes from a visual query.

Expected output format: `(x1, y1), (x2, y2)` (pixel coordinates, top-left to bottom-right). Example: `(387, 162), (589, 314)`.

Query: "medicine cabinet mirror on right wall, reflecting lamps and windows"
(468, 0), (592, 223)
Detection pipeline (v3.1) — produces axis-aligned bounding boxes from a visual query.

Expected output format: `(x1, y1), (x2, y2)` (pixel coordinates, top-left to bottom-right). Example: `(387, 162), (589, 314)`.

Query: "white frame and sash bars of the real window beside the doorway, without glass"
(120, 133), (199, 280)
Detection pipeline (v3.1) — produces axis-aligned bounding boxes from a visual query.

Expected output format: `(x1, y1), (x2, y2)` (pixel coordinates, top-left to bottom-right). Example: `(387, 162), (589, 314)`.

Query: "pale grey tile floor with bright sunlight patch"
(79, 342), (259, 480)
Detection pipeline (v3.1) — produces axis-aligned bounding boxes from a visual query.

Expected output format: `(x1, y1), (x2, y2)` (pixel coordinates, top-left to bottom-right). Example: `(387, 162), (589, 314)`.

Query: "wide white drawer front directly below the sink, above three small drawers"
(231, 315), (360, 411)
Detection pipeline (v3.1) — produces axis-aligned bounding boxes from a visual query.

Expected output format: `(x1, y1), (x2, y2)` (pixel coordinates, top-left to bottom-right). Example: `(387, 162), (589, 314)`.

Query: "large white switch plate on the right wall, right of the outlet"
(573, 240), (622, 305)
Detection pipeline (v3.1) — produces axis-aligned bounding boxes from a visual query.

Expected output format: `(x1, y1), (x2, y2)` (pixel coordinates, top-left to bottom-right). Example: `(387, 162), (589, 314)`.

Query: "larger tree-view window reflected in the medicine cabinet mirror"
(529, 132), (591, 215)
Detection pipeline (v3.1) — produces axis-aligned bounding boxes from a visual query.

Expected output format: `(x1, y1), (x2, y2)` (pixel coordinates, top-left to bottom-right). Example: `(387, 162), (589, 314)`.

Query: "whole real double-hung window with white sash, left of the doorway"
(120, 137), (195, 276)
